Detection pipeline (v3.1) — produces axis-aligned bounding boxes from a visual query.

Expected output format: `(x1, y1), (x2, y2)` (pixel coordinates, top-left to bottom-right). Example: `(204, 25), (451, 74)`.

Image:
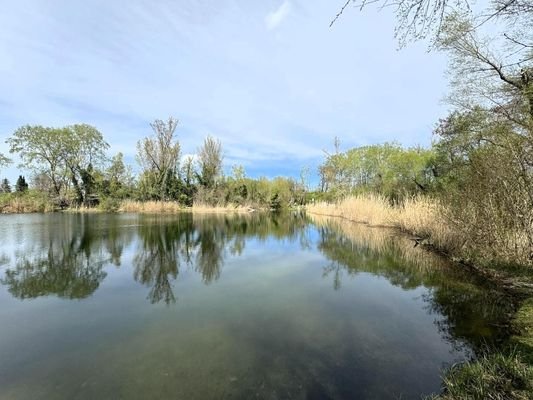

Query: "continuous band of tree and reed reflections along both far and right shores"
(0, 214), (512, 346)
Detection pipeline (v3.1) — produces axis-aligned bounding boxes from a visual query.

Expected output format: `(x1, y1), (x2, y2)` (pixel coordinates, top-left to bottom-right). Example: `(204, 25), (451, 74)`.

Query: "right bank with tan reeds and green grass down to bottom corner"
(307, 195), (533, 400)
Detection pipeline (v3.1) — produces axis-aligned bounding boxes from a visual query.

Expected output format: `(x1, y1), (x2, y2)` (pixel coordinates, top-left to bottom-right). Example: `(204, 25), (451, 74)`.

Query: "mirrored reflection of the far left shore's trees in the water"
(0, 214), (307, 304)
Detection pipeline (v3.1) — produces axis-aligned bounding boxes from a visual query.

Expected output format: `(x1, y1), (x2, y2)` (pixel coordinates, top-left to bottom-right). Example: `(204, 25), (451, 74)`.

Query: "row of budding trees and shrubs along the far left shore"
(0, 117), (305, 209)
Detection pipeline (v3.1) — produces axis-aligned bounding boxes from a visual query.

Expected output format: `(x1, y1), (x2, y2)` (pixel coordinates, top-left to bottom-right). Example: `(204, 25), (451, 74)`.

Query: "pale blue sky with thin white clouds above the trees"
(0, 0), (447, 184)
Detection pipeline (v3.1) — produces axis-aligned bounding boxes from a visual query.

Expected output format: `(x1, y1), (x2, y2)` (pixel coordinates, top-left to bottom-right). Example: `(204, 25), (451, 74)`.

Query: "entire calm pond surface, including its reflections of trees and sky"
(0, 214), (508, 400)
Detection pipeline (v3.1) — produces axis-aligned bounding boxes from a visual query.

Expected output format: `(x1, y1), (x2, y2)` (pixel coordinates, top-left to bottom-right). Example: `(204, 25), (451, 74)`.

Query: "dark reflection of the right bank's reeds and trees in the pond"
(316, 220), (513, 358)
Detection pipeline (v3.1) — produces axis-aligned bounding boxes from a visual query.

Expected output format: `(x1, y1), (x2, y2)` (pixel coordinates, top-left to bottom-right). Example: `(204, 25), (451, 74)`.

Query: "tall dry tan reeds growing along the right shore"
(306, 194), (533, 266)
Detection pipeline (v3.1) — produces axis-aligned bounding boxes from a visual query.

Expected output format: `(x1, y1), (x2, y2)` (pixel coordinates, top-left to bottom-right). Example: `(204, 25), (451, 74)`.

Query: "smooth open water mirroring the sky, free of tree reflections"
(0, 216), (486, 398)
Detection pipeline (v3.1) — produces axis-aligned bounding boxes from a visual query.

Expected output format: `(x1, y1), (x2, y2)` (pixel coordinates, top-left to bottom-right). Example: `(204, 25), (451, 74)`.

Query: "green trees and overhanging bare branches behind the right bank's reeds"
(319, 0), (533, 264)
